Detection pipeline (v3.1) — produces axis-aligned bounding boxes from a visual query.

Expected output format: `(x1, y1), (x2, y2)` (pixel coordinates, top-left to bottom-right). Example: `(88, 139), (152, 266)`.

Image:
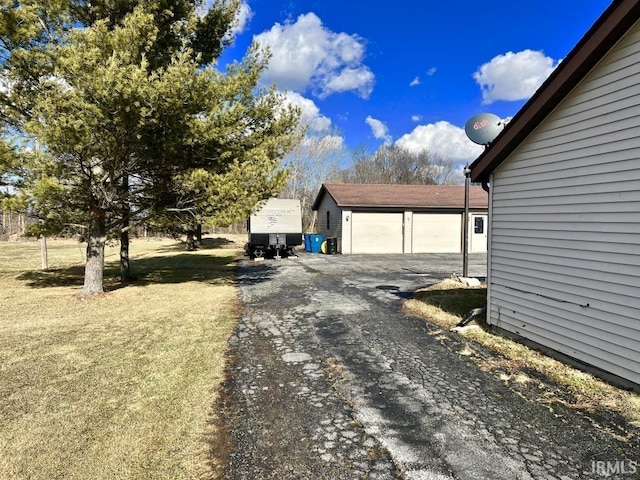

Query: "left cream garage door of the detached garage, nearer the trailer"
(351, 212), (403, 253)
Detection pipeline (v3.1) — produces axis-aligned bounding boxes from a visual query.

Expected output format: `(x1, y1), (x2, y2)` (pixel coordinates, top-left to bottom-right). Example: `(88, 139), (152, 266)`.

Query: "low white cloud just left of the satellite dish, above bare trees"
(396, 121), (483, 162)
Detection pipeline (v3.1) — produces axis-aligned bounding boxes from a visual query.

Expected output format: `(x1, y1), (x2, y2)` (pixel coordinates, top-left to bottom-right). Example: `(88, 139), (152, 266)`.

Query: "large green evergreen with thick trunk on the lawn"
(0, 0), (298, 294)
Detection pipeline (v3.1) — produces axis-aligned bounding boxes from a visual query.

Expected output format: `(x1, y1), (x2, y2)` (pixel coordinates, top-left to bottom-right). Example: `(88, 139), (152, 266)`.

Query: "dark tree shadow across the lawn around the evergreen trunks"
(17, 249), (245, 291)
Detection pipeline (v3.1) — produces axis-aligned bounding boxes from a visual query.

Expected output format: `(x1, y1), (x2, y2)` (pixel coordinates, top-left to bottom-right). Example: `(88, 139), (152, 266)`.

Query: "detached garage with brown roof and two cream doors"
(313, 183), (488, 254)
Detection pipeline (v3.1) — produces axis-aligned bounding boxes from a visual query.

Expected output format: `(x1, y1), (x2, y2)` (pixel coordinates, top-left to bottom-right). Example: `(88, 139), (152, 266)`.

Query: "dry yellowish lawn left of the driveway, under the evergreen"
(0, 239), (241, 480)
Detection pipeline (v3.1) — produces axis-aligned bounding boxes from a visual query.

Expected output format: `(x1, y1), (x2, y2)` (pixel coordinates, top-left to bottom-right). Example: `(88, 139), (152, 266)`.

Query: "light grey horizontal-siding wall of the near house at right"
(488, 19), (640, 384)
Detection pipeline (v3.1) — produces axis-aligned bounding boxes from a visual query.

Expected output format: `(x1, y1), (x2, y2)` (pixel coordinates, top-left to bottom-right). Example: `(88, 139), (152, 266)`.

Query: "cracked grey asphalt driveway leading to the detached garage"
(224, 252), (640, 480)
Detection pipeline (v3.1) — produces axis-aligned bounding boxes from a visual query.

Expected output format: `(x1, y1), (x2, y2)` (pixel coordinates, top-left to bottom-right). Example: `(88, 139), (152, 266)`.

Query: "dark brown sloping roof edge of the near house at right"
(471, 0), (640, 182)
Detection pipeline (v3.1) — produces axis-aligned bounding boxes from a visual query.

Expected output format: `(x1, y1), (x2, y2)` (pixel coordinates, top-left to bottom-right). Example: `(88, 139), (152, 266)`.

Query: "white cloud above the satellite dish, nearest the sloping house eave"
(473, 50), (558, 104)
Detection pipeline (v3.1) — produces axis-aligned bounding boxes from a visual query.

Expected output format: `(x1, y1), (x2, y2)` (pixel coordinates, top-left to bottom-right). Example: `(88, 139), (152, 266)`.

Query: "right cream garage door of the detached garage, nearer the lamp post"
(412, 213), (462, 253)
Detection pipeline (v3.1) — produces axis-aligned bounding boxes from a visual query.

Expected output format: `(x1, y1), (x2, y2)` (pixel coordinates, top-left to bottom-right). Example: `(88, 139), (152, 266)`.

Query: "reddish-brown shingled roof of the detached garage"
(313, 183), (489, 210)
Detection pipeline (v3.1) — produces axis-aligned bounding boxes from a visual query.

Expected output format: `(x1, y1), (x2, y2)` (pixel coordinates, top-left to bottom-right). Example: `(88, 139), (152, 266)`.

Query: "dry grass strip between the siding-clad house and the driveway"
(405, 280), (640, 430)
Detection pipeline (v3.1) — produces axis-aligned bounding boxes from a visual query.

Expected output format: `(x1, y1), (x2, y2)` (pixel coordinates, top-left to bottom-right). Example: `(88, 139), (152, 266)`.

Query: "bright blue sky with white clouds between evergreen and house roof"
(220, 0), (611, 163)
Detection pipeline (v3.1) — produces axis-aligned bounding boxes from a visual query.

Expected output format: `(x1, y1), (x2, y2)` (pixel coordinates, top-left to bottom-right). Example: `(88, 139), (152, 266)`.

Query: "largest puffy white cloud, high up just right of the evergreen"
(254, 13), (375, 98)
